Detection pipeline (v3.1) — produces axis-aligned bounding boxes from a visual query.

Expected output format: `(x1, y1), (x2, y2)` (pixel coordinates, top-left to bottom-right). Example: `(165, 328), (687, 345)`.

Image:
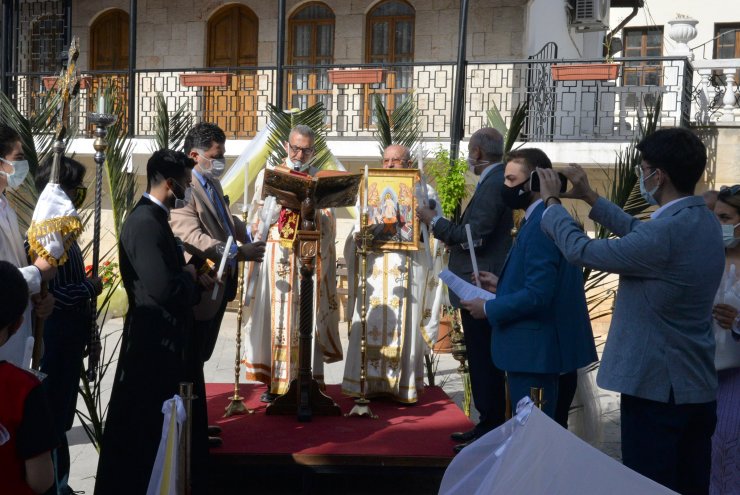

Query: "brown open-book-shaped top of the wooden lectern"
(262, 167), (362, 210)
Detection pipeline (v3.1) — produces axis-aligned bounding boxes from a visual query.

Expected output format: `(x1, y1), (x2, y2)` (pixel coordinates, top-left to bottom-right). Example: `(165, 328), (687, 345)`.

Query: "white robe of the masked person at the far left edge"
(0, 194), (41, 367)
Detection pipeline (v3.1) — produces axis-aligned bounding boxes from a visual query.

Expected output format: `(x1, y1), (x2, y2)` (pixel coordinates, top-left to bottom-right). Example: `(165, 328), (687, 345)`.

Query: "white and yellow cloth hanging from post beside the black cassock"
(146, 395), (187, 495)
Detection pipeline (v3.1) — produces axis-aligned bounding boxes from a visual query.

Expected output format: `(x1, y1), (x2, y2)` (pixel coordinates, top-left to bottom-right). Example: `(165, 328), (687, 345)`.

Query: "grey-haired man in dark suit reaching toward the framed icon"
(417, 128), (513, 451)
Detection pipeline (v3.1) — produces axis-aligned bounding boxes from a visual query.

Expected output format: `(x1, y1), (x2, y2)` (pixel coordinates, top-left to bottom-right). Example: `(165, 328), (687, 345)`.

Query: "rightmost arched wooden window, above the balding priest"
(364, 0), (416, 126)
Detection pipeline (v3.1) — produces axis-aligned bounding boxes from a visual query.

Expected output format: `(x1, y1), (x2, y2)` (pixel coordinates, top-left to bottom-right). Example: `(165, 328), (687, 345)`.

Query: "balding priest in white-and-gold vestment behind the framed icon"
(342, 145), (443, 403)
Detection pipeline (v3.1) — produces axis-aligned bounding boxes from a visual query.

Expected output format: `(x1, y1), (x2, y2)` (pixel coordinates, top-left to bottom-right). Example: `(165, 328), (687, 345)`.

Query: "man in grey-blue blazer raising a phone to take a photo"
(538, 128), (724, 494)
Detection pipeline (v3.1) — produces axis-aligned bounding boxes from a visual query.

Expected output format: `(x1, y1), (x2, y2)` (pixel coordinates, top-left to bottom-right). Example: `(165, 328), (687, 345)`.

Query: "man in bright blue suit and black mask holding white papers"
(461, 148), (596, 418)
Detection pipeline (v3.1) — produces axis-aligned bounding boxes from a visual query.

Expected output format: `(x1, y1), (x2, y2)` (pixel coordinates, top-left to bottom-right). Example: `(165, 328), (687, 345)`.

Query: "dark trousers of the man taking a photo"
(621, 393), (717, 495)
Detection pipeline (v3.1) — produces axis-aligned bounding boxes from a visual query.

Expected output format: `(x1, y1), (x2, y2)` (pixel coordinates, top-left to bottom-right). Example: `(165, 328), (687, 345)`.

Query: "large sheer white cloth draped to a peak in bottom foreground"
(439, 397), (675, 495)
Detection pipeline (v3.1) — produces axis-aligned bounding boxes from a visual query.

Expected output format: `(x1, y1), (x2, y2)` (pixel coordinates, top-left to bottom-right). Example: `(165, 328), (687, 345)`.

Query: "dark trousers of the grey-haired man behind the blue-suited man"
(460, 309), (506, 435)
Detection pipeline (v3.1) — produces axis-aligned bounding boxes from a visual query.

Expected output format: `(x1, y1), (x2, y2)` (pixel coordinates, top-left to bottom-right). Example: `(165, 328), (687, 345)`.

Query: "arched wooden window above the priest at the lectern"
(288, 2), (334, 112)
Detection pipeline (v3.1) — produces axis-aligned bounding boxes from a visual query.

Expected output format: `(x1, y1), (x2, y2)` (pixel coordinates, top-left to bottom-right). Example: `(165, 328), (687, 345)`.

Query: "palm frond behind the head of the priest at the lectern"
(267, 102), (331, 168)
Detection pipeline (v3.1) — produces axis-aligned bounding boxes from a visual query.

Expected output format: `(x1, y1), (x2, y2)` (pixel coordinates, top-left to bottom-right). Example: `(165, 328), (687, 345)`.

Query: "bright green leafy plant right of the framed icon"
(424, 148), (470, 218)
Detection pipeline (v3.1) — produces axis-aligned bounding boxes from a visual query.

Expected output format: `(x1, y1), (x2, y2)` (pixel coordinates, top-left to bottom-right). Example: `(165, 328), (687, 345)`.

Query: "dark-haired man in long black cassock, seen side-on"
(95, 150), (205, 495)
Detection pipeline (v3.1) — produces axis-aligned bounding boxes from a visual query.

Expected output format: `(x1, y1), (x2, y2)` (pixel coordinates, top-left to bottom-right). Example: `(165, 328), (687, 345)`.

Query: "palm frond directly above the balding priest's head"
(373, 94), (421, 154)
